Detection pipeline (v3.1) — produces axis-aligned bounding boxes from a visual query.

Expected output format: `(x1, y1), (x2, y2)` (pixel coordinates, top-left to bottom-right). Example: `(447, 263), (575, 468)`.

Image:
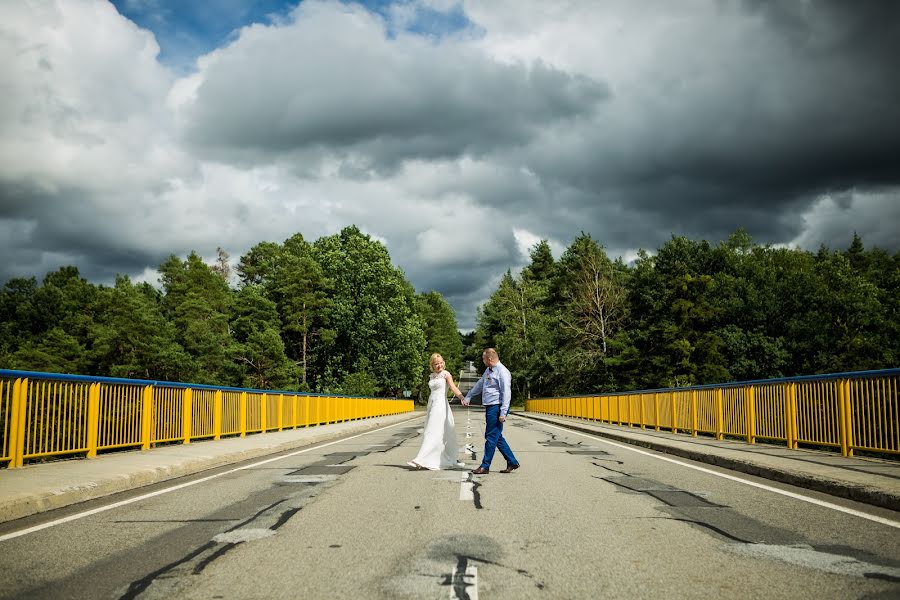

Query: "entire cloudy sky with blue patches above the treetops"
(0, 0), (900, 330)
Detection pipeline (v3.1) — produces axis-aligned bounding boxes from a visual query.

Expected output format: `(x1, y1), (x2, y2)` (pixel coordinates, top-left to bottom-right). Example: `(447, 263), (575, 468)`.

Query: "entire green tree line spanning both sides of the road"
(0, 226), (900, 399)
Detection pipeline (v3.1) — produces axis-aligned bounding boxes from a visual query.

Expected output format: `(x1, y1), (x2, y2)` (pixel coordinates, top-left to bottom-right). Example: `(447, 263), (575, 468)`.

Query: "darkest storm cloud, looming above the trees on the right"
(506, 2), (900, 249)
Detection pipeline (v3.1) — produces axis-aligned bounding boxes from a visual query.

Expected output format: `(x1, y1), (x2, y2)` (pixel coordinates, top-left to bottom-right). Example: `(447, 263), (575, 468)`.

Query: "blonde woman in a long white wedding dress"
(406, 354), (465, 471)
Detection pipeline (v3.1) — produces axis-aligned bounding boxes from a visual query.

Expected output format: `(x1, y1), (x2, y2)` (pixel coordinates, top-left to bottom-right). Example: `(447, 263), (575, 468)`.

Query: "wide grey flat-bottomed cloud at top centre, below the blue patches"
(178, 7), (609, 169)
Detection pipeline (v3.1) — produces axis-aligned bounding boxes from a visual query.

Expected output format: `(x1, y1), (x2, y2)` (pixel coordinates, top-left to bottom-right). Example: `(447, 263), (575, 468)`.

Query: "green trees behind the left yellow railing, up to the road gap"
(0, 226), (462, 397)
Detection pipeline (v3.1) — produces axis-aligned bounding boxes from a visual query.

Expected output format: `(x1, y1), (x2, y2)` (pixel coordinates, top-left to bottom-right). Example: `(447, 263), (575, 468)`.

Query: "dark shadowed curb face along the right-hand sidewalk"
(515, 413), (900, 511)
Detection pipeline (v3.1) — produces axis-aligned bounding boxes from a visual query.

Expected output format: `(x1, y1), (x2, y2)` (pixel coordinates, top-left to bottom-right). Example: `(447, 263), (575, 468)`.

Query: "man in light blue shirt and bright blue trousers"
(462, 348), (519, 475)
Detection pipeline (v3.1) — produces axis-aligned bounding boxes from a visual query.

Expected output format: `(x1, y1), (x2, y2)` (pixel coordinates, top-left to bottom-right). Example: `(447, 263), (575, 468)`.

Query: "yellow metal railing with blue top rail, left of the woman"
(0, 370), (415, 468)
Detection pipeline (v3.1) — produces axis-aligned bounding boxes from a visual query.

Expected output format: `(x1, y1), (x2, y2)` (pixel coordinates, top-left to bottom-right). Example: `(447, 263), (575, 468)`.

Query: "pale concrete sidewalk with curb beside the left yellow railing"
(0, 413), (420, 523)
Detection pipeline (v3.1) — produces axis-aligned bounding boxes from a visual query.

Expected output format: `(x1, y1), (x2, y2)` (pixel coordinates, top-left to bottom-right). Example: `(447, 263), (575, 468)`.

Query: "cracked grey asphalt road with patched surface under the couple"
(0, 407), (900, 599)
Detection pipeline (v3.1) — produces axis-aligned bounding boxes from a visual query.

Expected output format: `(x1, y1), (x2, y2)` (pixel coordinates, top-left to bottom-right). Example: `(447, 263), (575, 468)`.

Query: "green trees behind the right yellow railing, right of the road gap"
(473, 230), (900, 398)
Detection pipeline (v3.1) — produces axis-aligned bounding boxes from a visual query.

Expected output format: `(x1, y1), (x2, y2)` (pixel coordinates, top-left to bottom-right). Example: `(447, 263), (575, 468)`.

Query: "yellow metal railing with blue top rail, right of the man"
(525, 369), (900, 456)
